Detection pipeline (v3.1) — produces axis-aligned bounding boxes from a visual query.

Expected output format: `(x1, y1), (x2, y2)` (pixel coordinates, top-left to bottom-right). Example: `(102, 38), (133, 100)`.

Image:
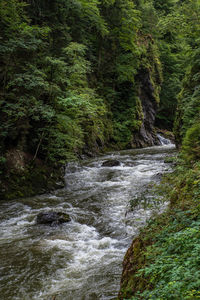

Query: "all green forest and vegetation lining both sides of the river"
(0, 0), (200, 299)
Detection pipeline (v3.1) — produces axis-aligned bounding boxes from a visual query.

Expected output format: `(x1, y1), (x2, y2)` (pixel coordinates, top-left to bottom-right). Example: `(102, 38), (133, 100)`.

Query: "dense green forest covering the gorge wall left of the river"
(0, 0), (177, 198)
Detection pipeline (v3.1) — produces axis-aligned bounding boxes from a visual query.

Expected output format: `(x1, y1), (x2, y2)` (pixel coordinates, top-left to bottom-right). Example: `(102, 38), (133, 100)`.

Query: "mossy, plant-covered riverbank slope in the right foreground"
(118, 154), (200, 300)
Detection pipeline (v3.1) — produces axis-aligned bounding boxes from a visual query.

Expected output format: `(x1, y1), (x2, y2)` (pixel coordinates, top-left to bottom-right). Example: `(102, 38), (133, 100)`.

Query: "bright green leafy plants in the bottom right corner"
(136, 213), (200, 299)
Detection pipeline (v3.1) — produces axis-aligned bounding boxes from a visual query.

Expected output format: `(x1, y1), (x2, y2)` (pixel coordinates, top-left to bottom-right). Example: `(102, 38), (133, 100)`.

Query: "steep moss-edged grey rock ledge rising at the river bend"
(131, 35), (163, 148)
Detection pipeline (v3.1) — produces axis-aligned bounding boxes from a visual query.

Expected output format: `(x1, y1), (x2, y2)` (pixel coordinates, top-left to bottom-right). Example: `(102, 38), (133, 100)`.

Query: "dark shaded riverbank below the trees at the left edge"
(0, 150), (64, 200)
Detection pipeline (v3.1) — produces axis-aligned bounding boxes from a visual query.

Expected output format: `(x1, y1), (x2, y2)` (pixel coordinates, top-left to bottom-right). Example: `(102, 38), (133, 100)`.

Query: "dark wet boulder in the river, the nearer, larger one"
(36, 211), (70, 226)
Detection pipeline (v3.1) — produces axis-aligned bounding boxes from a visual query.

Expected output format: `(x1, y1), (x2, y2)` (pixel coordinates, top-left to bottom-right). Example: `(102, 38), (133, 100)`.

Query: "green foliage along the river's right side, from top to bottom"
(120, 0), (200, 288)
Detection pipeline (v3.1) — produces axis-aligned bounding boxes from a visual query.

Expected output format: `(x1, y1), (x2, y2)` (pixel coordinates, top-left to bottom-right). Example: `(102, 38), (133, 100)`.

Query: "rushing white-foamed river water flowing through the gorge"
(0, 144), (174, 300)
